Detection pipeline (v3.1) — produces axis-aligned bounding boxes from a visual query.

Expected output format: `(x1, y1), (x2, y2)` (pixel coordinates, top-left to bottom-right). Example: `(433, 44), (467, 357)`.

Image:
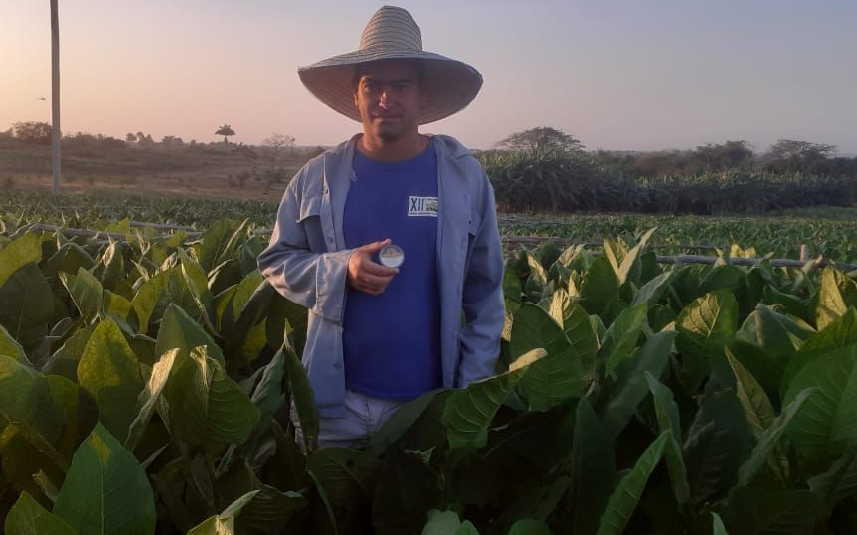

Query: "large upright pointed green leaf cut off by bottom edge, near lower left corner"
(54, 424), (155, 535)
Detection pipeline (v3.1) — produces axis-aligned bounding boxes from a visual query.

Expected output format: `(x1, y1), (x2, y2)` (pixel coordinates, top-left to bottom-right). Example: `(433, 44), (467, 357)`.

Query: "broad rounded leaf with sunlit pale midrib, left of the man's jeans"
(158, 346), (259, 447)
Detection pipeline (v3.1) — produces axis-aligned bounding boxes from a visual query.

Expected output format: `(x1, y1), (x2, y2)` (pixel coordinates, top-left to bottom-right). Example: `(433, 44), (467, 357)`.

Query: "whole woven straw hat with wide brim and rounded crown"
(298, 6), (482, 124)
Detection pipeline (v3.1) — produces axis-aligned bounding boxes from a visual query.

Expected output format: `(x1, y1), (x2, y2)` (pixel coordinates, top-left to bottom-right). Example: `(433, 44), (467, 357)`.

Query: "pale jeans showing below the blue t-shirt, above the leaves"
(290, 390), (406, 449)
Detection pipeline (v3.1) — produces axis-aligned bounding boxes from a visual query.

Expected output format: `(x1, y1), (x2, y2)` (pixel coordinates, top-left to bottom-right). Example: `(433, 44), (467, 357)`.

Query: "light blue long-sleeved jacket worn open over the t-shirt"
(258, 135), (503, 417)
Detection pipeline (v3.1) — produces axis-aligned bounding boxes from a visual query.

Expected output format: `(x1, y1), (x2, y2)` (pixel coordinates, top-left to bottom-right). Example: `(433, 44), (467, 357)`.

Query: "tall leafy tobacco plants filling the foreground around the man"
(0, 218), (857, 535)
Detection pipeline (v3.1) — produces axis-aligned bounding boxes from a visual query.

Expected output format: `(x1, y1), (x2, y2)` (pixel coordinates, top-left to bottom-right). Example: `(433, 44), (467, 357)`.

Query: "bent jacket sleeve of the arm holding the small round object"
(257, 169), (354, 322)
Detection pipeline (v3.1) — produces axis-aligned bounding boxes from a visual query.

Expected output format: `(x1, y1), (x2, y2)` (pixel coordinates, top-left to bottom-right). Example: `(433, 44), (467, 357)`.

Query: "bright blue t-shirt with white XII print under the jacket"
(342, 143), (443, 399)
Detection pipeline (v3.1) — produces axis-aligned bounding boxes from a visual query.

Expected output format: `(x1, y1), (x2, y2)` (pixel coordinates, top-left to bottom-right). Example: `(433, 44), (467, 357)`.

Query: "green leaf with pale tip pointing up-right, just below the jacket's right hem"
(442, 353), (541, 449)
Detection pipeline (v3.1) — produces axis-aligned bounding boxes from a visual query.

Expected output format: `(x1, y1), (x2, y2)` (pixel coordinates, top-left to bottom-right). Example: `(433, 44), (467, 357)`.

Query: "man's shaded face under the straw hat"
(354, 60), (425, 141)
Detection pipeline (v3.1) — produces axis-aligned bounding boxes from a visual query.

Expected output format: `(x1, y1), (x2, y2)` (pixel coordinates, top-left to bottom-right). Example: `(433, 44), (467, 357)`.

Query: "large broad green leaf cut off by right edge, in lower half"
(783, 344), (857, 460)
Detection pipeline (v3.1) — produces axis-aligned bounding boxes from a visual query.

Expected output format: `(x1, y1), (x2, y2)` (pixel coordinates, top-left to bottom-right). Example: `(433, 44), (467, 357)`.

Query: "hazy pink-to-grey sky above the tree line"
(0, 0), (857, 155)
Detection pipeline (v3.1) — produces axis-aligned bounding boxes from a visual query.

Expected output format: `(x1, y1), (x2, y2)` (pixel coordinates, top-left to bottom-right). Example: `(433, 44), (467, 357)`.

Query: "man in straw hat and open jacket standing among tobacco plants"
(258, 6), (503, 447)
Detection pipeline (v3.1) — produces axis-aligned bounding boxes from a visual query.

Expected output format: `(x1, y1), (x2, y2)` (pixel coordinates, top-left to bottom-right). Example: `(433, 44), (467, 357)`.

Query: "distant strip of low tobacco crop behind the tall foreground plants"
(0, 190), (857, 264)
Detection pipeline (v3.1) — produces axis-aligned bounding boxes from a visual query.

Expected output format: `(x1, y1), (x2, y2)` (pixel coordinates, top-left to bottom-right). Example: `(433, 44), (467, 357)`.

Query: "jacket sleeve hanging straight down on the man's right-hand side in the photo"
(455, 177), (504, 387)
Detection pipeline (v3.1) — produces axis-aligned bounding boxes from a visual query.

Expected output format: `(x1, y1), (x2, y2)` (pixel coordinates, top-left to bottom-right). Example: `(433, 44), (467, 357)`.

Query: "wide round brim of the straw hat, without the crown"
(298, 50), (482, 124)
